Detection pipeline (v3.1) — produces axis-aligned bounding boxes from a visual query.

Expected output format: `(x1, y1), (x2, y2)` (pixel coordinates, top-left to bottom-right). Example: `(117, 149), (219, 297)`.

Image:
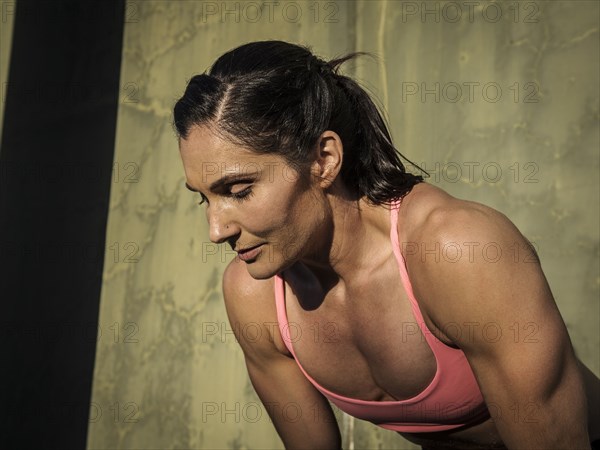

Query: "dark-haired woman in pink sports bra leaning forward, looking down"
(174, 41), (600, 449)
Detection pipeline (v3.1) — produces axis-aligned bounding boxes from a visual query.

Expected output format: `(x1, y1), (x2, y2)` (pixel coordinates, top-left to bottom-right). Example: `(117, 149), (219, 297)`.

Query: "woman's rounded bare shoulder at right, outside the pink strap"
(398, 184), (540, 334)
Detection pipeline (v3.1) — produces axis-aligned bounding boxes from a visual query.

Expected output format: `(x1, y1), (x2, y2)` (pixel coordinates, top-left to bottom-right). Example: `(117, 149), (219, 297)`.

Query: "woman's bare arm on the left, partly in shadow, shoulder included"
(223, 261), (341, 450)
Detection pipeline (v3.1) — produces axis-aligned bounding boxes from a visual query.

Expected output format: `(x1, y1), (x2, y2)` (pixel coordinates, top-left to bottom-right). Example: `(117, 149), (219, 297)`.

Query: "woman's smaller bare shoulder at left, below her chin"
(222, 259), (288, 356)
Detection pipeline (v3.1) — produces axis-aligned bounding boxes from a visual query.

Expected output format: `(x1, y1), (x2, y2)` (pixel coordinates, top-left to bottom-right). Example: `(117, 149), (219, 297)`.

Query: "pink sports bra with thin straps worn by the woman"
(275, 200), (489, 433)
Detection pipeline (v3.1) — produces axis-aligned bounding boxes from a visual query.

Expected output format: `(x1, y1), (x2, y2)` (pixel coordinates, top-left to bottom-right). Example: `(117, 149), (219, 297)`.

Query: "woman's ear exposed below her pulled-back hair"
(311, 130), (344, 189)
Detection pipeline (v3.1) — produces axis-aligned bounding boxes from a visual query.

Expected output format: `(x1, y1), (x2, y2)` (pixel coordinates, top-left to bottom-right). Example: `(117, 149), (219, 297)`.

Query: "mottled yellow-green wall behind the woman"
(89, 0), (600, 449)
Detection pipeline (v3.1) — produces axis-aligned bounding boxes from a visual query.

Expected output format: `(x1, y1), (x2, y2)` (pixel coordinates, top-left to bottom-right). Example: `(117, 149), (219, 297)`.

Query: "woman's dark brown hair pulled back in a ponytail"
(174, 41), (423, 205)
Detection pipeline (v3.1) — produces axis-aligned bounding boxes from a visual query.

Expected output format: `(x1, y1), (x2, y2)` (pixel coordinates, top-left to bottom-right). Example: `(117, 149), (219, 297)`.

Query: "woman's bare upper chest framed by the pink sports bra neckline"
(278, 259), (436, 401)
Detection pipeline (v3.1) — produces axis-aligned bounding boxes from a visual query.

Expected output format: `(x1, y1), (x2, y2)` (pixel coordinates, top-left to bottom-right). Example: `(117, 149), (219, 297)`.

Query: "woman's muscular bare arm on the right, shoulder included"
(407, 200), (590, 450)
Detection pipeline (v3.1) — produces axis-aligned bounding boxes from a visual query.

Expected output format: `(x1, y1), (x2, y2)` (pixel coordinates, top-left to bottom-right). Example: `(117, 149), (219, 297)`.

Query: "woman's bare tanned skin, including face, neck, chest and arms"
(180, 126), (600, 449)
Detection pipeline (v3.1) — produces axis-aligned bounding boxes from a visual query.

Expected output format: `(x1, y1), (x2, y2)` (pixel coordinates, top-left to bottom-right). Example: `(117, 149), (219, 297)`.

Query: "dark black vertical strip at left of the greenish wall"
(0, 0), (124, 449)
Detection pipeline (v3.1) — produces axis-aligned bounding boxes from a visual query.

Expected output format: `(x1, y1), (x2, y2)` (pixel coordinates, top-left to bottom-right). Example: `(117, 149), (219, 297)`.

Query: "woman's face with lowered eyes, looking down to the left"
(179, 126), (329, 279)
